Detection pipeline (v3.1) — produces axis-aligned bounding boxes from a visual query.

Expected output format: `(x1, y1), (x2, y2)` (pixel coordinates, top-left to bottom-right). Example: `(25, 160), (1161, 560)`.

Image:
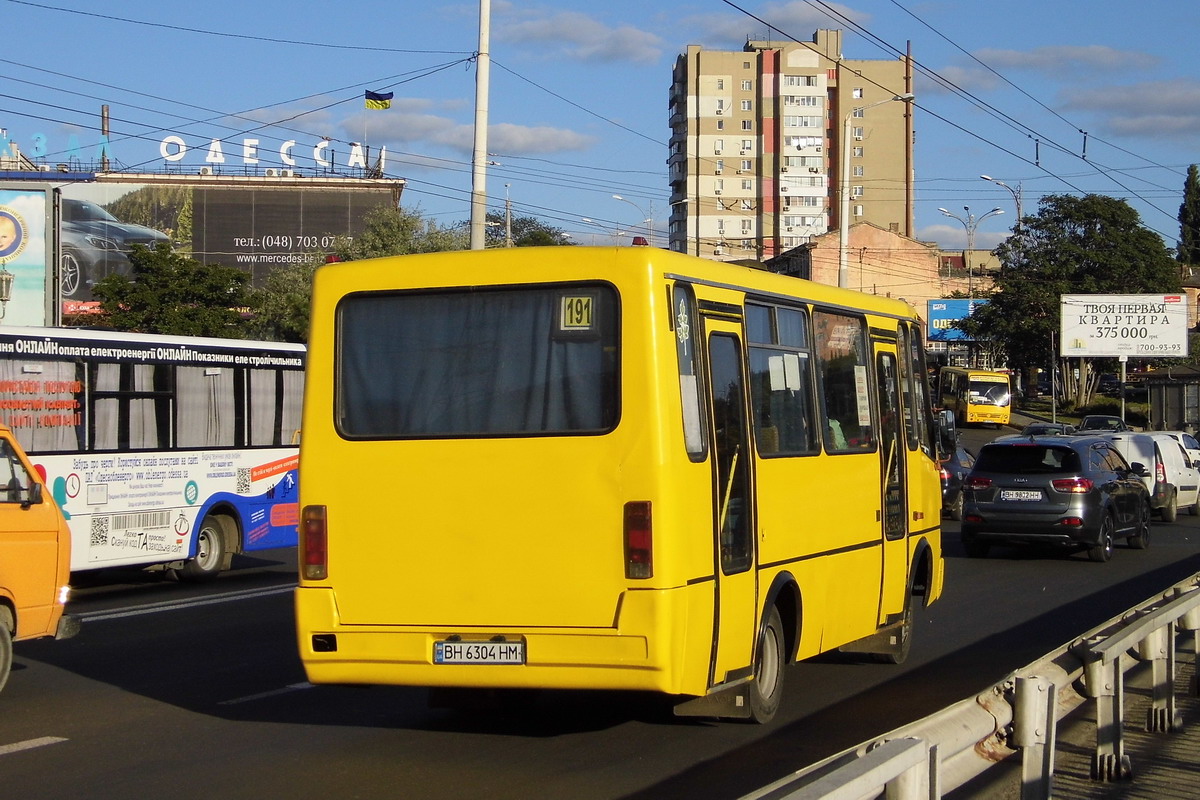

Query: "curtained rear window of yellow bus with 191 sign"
(336, 283), (619, 439)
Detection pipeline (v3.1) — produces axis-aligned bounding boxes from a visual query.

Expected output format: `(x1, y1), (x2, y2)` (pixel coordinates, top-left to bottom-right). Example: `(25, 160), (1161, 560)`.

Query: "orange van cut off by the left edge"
(0, 425), (79, 690)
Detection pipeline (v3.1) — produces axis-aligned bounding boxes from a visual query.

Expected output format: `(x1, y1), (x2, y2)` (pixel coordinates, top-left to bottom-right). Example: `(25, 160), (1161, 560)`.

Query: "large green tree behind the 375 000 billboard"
(959, 194), (1180, 405)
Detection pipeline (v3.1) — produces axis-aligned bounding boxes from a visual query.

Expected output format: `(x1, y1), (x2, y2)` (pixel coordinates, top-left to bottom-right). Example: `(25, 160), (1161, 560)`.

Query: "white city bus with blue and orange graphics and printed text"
(0, 327), (305, 579)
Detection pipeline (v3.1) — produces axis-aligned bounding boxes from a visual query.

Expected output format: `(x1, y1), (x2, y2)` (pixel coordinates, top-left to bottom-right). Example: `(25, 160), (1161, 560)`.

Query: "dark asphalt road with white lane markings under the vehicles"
(7, 443), (1200, 800)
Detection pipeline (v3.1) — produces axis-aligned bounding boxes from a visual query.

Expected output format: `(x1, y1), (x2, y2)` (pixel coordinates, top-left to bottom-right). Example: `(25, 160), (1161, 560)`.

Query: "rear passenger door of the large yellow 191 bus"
(707, 319), (757, 685)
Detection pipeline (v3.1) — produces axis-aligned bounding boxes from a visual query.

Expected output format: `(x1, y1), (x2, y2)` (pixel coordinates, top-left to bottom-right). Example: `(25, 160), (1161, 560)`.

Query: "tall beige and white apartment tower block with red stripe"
(667, 30), (912, 260)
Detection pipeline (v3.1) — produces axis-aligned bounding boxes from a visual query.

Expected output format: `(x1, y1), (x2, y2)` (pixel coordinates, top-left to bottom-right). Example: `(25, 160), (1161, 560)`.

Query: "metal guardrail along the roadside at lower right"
(743, 573), (1200, 800)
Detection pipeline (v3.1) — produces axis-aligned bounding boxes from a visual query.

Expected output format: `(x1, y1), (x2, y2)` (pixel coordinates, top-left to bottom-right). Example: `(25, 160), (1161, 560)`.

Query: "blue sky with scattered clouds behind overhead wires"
(0, 0), (1200, 248)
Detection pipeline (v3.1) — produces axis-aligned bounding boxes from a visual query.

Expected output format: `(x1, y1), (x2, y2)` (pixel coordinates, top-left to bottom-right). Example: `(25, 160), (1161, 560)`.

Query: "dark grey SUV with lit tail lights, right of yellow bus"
(962, 435), (1150, 561)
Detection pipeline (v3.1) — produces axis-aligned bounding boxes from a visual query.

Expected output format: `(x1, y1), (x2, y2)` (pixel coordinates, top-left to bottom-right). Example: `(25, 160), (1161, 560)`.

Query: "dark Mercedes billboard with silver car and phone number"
(59, 176), (398, 313)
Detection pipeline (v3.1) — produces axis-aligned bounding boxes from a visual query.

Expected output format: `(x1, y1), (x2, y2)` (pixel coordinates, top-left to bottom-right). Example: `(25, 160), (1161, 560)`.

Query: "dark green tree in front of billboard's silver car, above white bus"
(92, 242), (250, 338)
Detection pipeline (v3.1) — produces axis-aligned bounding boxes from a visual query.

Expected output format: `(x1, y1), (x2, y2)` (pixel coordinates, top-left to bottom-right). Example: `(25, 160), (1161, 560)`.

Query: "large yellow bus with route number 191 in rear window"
(295, 246), (953, 722)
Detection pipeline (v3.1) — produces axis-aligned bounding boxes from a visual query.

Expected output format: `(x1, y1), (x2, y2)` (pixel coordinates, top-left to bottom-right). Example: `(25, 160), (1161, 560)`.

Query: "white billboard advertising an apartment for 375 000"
(1058, 294), (1188, 357)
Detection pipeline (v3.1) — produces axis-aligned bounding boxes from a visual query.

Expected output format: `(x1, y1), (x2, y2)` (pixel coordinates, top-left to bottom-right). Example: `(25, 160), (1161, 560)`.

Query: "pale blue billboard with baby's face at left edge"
(0, 187), (50, 325)
